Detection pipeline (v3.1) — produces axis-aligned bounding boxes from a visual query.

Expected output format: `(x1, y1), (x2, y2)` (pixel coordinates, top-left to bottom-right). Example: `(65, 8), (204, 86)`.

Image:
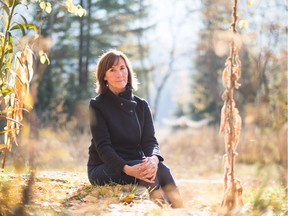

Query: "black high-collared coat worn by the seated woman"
(88, 90), (163, 173)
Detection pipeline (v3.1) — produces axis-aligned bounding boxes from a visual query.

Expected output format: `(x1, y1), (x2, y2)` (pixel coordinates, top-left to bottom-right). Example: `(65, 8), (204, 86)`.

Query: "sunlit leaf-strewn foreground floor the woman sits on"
(0, 167), (287, 216)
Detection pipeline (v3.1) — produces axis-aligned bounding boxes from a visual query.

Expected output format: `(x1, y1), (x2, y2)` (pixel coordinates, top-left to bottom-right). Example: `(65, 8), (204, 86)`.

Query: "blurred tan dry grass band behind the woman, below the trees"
(7, 126), (287, 179)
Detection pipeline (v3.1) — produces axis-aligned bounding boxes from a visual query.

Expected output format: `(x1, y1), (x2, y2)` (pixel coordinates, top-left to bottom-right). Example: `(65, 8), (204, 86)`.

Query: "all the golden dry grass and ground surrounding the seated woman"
(0, 124), (287, 215)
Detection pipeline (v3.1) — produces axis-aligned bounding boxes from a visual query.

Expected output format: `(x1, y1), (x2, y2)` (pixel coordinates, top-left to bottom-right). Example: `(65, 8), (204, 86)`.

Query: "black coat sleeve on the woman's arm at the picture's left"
(89, 102), (126, 173)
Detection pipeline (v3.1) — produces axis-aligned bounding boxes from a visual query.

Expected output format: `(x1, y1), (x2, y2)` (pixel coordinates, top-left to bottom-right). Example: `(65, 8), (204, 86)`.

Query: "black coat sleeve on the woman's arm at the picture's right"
(141, 101), (164, 161)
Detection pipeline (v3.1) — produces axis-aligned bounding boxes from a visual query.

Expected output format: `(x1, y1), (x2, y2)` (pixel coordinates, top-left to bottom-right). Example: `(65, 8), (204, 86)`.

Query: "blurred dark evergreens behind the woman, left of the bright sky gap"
(35, 0), (152, 130)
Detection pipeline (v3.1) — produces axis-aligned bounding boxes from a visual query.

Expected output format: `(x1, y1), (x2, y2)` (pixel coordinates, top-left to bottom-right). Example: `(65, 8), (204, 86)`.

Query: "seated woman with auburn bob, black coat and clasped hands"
(88, 50), (183, 208)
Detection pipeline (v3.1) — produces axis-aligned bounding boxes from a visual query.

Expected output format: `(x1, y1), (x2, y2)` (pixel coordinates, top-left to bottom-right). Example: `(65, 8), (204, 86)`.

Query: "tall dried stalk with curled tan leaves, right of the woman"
(220, 0), (243, 215)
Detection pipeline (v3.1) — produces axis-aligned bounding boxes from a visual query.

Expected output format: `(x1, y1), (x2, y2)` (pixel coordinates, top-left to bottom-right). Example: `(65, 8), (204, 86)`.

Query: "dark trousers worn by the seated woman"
(88, 160), (176, 189)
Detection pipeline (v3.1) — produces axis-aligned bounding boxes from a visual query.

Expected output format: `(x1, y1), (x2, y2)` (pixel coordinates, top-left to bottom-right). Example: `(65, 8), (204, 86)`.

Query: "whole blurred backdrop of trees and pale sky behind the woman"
(6, 0), (287, 130)
